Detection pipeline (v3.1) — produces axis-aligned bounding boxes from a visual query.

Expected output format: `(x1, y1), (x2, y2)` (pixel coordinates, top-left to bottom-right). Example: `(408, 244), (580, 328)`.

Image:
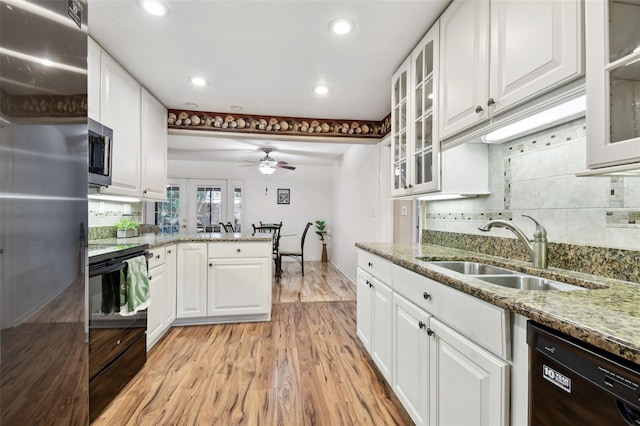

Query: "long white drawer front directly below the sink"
(393, 265), (510, 359)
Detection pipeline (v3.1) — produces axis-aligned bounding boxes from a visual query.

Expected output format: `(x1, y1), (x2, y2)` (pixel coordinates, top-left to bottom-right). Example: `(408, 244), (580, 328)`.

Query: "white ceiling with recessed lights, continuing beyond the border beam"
(89, 0), (450, 165)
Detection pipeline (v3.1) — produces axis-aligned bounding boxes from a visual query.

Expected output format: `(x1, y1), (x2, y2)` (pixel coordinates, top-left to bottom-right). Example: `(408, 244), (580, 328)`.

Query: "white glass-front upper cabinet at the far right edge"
(585, 0), (640, 169)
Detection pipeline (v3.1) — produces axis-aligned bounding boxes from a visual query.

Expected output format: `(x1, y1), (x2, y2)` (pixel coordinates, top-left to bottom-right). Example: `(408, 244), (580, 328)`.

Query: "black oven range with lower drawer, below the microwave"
(87, 244), (151, 421)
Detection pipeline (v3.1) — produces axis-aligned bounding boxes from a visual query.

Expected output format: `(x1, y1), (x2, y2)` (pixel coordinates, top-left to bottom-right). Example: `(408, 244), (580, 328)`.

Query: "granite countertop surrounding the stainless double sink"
(356, 243), (640, 364)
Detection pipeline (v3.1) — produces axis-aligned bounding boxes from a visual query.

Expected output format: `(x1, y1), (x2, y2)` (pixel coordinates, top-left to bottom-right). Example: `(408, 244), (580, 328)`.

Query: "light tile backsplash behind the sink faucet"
(422, 118), (640, 250)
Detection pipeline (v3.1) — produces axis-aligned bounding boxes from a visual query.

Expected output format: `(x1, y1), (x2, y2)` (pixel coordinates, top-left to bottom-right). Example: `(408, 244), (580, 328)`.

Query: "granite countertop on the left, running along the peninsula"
(89, 233), (272, 248)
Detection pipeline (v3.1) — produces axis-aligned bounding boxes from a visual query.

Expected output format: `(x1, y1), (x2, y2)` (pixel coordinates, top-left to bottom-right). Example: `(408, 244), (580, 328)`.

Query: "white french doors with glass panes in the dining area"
(147, 179), (243, 234)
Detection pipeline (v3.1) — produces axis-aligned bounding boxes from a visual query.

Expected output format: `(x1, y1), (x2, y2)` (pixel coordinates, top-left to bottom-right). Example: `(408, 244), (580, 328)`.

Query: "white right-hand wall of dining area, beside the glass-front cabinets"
(328, 144), (390, 282)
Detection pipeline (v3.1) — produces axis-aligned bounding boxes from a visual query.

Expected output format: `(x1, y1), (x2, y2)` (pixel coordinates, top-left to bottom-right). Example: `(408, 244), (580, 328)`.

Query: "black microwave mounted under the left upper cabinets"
(89, 119), (113, 186)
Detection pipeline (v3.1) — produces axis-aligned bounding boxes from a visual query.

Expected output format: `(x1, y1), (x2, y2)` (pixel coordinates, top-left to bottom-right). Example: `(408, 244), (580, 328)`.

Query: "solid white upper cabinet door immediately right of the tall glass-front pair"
(439, 0), (489, 139)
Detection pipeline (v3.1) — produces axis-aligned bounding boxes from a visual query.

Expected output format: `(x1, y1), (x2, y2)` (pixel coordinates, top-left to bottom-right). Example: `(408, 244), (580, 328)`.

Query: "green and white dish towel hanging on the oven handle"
(120, 256), (151, 316)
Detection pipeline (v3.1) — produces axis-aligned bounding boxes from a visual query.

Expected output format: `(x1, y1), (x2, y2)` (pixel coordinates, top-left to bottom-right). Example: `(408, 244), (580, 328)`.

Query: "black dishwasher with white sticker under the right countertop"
(527, 321), (640, 426)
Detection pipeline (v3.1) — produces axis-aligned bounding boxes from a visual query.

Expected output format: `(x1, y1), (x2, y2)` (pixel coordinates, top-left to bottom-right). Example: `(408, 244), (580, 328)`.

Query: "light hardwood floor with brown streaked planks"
(93, 262), (413, 426)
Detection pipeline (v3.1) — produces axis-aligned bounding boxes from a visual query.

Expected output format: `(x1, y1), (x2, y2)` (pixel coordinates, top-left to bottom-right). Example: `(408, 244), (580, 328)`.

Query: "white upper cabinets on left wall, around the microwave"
(88, 38), (167, 200)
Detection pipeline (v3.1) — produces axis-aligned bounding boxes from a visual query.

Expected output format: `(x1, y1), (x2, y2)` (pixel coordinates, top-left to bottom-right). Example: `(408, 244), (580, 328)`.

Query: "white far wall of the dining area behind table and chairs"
(168, 160), (333, 260)
